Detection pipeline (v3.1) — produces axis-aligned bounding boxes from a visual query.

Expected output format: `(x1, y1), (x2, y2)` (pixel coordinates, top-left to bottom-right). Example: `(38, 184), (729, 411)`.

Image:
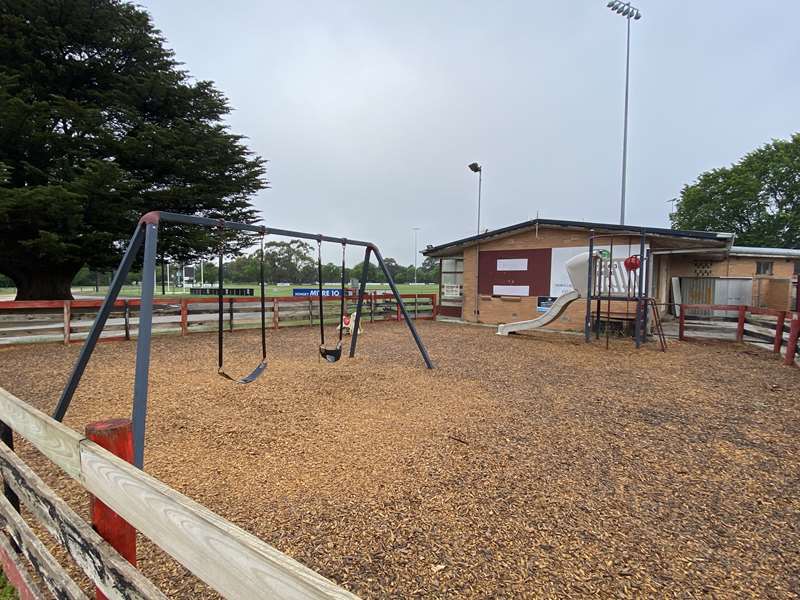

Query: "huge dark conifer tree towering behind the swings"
(0, 0), (266, 299)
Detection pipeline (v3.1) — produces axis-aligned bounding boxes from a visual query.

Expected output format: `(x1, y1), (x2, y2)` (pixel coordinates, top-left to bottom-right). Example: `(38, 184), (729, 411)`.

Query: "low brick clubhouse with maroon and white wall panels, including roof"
(423, 219), (800, 330)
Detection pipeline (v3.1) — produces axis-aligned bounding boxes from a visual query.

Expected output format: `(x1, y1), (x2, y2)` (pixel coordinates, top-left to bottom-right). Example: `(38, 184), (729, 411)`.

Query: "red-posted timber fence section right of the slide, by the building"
(678, 304), (800, 365)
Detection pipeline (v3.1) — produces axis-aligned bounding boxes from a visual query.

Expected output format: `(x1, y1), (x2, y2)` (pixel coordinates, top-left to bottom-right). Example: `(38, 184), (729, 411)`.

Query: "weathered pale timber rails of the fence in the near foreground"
(0, 388), (355, 600)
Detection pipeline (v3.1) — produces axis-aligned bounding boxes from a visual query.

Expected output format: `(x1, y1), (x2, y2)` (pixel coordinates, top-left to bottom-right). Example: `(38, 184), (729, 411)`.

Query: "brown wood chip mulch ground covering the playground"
(0, 322), (800, 598)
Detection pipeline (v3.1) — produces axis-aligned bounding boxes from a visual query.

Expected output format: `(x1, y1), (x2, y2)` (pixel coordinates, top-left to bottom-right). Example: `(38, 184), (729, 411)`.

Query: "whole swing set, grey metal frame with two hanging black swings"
(53, 211), (433, 469)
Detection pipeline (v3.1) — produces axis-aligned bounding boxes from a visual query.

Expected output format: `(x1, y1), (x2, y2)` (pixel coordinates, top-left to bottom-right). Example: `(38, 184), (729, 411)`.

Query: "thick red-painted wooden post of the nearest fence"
(86, 419), (136, 600)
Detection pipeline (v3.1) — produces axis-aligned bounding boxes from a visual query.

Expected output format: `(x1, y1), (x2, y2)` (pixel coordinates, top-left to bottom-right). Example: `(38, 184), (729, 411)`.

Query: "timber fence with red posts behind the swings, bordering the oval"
(0, 292), (438, 345)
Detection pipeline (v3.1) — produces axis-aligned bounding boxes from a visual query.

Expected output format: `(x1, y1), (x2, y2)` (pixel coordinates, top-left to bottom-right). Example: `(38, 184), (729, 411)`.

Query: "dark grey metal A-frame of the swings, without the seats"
(53, 211), (433, 469)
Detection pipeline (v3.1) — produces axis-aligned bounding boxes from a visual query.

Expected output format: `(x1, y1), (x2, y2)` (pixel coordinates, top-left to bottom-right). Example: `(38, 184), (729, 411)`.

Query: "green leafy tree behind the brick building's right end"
(671, 133), (800, 248)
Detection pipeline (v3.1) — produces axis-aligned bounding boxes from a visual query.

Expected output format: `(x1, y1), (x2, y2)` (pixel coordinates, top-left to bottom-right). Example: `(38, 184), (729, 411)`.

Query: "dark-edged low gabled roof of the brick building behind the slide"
(422, 219), (733, 256)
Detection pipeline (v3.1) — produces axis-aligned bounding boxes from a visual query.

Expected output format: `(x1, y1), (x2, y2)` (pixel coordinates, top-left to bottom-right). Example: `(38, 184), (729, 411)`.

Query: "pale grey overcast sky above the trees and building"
(134, 0), (800, 264)
